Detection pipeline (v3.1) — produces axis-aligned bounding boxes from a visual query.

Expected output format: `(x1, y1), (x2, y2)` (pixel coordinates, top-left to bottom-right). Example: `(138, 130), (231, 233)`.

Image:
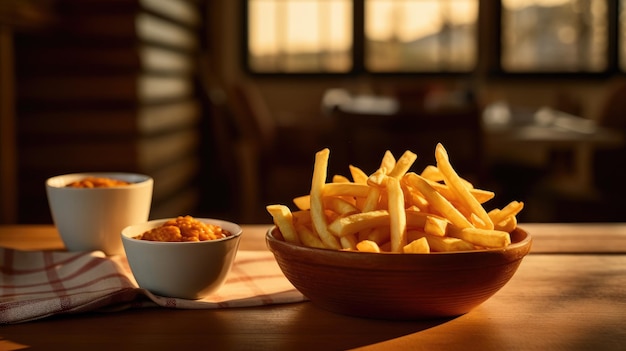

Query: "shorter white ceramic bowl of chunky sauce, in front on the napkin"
(122, 218), (242, 300)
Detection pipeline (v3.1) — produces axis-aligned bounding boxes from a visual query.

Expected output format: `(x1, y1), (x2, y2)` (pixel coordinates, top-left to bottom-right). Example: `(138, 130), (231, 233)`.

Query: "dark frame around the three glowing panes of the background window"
(240, 0), (626, 80)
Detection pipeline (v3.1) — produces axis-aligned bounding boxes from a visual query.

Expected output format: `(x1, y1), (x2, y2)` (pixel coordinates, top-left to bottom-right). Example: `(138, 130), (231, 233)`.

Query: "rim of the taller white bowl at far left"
(46, 172), (154, 191)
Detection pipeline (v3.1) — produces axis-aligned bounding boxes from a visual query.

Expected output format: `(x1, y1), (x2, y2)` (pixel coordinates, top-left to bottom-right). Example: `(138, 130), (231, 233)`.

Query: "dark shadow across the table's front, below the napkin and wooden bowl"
(0, 303), (454, 351)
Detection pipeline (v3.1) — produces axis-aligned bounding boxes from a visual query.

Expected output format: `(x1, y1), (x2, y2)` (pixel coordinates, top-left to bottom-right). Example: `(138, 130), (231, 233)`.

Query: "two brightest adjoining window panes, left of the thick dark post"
(245, 0), (478, 73)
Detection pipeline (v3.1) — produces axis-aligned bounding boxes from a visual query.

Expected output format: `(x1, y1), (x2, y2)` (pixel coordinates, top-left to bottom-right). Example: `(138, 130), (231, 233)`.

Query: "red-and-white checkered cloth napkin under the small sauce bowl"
(0, 248), (306, 324)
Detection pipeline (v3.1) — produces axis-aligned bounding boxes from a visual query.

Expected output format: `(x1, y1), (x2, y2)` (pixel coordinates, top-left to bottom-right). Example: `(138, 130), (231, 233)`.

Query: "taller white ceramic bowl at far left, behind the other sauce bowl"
(46, 172), (154, 255)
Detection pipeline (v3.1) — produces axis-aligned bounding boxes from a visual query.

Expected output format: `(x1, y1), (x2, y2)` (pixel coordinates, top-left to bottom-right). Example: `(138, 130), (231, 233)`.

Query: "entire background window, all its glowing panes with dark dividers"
(244, 0), (626, 75)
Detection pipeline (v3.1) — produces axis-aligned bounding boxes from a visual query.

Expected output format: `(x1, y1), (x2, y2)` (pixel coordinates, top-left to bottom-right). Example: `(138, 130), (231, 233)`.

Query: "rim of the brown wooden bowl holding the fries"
(265, 225), (533, 257)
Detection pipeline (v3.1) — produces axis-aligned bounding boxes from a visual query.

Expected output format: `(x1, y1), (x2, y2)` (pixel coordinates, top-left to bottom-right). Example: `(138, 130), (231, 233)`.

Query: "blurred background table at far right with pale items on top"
(483, 103), (624, 195)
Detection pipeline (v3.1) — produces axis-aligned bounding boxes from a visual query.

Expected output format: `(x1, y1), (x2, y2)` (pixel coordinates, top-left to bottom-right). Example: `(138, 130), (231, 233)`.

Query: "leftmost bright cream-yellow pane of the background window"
(248, 0), (352, 73)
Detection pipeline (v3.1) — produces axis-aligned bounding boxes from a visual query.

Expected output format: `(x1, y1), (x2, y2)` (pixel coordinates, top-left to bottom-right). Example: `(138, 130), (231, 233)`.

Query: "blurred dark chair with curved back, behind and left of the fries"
(228, 81), (332, 223)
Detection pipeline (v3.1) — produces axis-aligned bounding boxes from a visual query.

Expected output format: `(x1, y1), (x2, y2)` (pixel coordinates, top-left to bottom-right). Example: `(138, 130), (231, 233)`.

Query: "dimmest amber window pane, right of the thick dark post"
(502, 0), (608, 72)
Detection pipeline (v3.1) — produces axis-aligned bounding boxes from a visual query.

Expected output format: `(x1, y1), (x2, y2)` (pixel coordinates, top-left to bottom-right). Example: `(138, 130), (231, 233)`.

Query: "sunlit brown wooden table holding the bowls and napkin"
(0, 223), (626, 351)
